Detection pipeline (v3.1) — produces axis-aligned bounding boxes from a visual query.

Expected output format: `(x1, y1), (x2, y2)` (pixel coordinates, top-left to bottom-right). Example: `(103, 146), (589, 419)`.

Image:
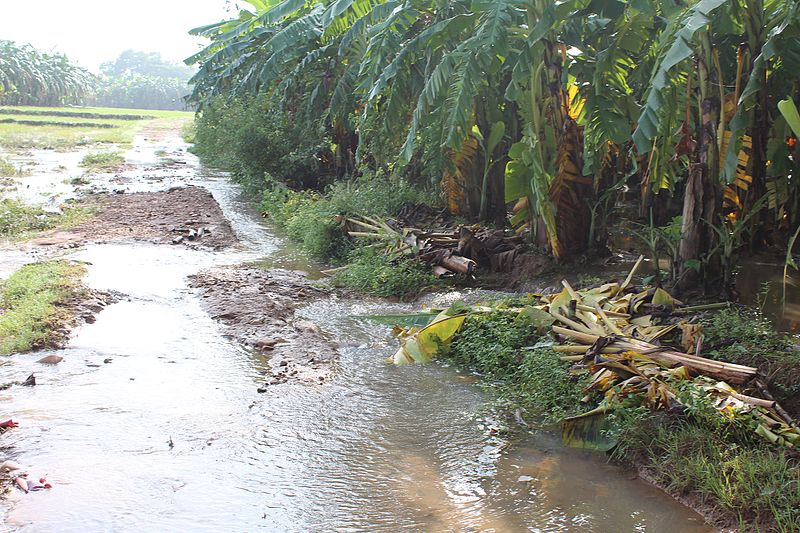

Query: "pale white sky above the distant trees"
(0, 0), (241, 71)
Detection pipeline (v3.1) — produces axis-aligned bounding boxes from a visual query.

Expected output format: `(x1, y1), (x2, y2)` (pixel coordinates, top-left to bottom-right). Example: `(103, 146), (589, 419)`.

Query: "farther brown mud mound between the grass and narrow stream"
(30, 186), (237, 250)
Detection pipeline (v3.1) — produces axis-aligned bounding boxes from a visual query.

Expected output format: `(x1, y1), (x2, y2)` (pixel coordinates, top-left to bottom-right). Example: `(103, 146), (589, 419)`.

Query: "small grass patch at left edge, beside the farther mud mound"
(0, 198), (92, 240)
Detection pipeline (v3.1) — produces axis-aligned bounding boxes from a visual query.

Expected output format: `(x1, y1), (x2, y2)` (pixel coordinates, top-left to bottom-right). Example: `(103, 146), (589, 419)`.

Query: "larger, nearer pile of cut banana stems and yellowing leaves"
(394, 257), (800, 447)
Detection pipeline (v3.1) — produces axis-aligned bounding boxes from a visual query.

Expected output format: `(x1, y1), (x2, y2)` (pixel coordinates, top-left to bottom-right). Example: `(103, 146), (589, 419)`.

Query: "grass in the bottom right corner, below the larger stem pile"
(613, 408), (800, 532)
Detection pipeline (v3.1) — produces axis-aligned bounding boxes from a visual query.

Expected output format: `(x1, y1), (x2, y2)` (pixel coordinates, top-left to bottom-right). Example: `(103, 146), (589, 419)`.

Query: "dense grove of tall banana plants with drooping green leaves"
(187, 0), (800, 287)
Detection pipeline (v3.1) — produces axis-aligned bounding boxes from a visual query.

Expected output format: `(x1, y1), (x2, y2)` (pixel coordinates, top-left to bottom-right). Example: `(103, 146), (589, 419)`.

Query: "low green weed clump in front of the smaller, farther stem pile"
(331, 248), (438, 298)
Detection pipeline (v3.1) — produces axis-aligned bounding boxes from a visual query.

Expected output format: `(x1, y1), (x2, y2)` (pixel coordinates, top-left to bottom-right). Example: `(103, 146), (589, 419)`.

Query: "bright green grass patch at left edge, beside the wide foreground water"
(0, 261), (85, 355)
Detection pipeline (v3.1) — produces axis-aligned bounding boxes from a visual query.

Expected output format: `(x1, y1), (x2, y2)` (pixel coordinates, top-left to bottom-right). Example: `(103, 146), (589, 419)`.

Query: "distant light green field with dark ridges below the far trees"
(0, 107), (194, 151)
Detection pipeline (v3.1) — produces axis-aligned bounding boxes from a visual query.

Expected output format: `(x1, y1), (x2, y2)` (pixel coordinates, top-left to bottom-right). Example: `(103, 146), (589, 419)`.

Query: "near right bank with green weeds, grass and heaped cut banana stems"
(380, 268), (800, 531)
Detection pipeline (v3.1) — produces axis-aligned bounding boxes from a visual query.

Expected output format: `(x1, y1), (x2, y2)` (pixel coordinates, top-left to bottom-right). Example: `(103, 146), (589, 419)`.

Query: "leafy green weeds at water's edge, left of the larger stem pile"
(442, 311), (586, 425)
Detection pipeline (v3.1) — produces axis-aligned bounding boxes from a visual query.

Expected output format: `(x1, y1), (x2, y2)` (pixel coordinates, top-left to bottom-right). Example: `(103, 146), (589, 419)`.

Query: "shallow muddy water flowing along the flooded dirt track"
(0, 135), (711, 532)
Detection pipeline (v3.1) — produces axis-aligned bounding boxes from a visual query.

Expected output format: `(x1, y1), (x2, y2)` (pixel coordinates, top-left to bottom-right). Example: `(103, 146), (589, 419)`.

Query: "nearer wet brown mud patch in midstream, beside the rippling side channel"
(189, 265), (336, 391)
